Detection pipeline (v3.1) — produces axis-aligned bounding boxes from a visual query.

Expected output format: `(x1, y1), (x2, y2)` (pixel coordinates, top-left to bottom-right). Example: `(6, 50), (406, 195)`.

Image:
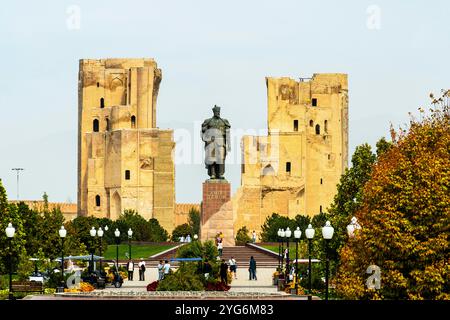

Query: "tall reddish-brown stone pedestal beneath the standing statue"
(200, 179), (234, 246)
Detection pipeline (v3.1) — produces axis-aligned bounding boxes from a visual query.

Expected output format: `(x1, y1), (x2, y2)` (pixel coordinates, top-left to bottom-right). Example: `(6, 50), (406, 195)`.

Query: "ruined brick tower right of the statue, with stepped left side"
(233, 73), (348, 231)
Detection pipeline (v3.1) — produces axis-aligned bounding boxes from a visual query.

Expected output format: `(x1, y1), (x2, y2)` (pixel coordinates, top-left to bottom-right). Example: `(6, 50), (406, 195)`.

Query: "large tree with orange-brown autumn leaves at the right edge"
(335, 91), (450, 299)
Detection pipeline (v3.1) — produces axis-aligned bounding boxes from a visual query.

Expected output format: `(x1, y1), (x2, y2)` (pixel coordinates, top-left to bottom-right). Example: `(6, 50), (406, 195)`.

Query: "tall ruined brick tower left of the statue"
(78, 58), (175, 232)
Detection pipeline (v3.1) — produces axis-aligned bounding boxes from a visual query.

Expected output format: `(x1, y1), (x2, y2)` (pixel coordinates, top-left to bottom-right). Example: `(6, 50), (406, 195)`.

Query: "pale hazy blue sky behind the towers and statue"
(0, 0), (450, 202)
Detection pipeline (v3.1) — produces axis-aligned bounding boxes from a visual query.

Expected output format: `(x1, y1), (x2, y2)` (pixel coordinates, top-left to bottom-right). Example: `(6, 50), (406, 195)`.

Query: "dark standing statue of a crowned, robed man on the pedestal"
(201, 105), (231, 179)
